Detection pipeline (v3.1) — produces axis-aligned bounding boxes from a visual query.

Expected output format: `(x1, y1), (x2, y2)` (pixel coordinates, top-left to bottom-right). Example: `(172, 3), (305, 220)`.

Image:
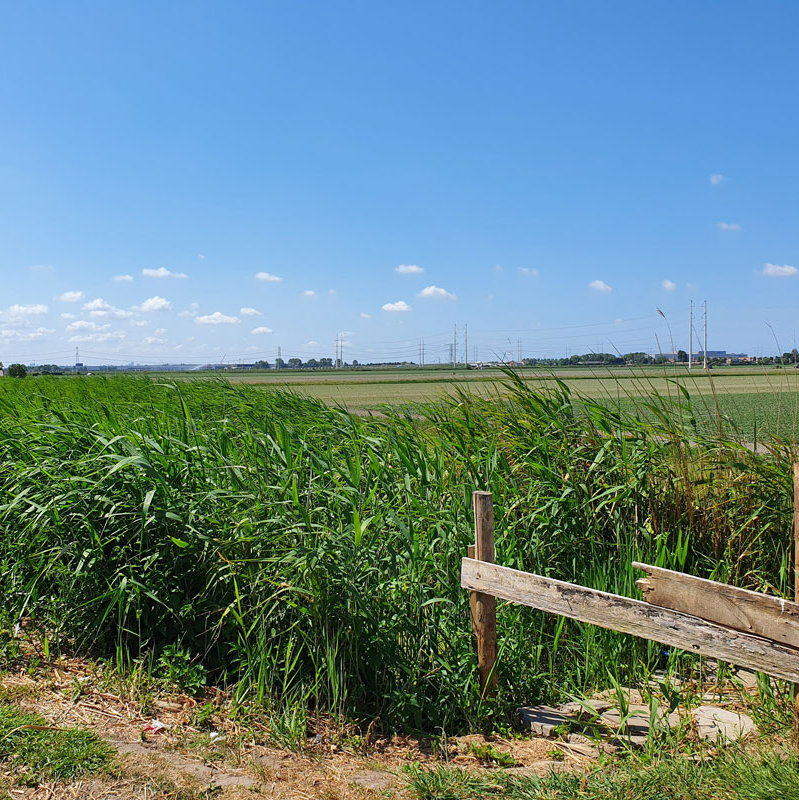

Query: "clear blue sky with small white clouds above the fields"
(0, 0), (799, 363)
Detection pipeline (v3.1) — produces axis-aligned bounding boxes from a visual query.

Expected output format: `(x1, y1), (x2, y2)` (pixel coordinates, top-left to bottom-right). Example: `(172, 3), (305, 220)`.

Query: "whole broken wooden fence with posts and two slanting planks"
(461, 464), (799, 741)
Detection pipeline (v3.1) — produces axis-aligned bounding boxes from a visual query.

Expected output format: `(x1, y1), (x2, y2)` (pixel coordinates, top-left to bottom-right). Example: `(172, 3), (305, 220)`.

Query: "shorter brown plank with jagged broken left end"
(633, 561), (799, 647)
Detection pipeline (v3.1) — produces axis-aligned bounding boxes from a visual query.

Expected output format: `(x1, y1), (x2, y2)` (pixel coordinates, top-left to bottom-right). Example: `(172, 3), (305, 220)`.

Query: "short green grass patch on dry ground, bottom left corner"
(0, 703), (114, 781)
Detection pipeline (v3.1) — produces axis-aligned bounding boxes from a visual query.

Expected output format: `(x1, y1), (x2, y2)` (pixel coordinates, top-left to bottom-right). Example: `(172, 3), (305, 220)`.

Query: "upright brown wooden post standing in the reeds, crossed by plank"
(469, 492), (497, 695)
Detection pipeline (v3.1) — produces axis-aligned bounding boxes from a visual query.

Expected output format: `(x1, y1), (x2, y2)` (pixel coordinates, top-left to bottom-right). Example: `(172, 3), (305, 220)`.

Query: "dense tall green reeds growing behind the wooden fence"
(0, 375), (792, 731)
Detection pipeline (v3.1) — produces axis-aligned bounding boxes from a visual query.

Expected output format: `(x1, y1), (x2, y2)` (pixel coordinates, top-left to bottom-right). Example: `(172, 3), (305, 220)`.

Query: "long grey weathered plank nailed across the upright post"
(461, 558), (799, 682)
